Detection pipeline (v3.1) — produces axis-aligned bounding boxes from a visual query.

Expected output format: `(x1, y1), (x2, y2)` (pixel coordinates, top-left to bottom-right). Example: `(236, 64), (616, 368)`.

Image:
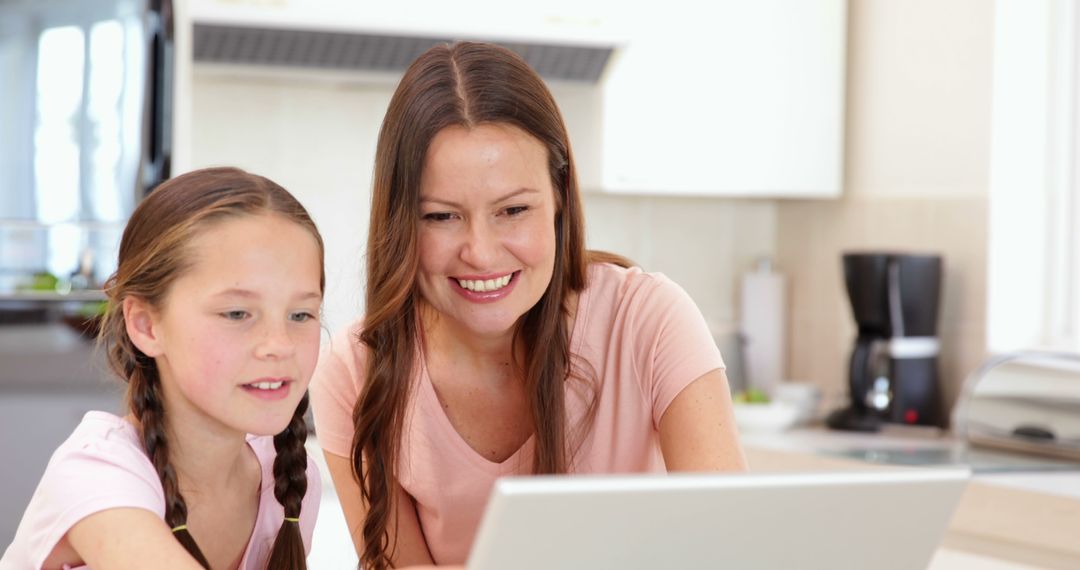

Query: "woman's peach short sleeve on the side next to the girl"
(310, 324), (364, 458)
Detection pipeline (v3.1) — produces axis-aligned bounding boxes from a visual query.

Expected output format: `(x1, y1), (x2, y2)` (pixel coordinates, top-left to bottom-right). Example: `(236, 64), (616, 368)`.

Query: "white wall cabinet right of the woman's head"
(599, 0), (847, 198)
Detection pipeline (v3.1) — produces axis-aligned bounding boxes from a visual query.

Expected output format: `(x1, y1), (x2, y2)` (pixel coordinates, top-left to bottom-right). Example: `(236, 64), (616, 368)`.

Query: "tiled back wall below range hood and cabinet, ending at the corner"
(190, 72), (777, 338)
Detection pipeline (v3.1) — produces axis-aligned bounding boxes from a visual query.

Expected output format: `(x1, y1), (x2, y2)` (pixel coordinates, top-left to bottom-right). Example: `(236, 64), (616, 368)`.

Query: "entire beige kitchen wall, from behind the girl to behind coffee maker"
(190, 0), (993, 418)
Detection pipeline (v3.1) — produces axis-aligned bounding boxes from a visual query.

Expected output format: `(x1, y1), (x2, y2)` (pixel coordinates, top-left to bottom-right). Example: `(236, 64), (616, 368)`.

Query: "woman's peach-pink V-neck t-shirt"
(311, 263), (724, 564)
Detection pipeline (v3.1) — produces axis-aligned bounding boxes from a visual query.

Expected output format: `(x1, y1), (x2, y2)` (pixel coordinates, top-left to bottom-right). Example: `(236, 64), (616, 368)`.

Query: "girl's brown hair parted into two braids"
(98, 168), (325, 570)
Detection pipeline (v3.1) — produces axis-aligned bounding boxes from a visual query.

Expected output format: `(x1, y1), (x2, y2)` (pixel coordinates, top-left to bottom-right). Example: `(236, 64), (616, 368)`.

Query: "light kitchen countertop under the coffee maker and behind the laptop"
(742, 429), (1080, 570)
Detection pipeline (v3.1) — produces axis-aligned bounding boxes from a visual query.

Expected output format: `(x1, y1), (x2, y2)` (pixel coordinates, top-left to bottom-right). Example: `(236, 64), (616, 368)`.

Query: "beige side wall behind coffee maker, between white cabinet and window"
(777, 0), (994, 418)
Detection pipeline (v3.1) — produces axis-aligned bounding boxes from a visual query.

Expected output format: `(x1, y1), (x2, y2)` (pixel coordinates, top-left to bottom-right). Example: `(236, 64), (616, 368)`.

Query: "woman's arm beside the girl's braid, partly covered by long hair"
(323, 450), (434, 567)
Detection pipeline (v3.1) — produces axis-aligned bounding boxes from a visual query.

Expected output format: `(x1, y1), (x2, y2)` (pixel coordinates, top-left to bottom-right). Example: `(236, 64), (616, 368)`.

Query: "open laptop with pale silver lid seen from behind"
(468, 467), (971, 570)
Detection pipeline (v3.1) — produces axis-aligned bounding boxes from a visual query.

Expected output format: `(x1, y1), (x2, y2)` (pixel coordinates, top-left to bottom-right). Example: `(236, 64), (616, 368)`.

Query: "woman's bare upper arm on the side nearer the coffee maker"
(660, 368), (746, 472)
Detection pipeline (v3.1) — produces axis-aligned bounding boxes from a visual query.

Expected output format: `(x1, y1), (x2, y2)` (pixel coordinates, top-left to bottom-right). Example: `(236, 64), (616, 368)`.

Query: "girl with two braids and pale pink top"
(0, 168), (324, 570)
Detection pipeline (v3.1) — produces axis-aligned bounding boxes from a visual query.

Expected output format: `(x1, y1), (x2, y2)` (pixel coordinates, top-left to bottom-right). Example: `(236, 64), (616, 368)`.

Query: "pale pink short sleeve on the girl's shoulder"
(21, 431), (165, 568)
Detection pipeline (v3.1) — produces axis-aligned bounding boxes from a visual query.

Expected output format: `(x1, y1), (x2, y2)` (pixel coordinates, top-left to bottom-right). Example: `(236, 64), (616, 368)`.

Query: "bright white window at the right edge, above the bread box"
(987, 0), (1080, 352)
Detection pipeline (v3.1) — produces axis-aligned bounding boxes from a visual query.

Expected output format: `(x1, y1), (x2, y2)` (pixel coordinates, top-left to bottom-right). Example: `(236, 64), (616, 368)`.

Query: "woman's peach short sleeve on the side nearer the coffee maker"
(633, 273), (724, 429)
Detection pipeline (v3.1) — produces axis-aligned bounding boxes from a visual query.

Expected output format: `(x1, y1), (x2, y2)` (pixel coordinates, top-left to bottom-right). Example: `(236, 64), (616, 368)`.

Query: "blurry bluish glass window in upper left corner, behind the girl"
(0, 0), (147, 282)
